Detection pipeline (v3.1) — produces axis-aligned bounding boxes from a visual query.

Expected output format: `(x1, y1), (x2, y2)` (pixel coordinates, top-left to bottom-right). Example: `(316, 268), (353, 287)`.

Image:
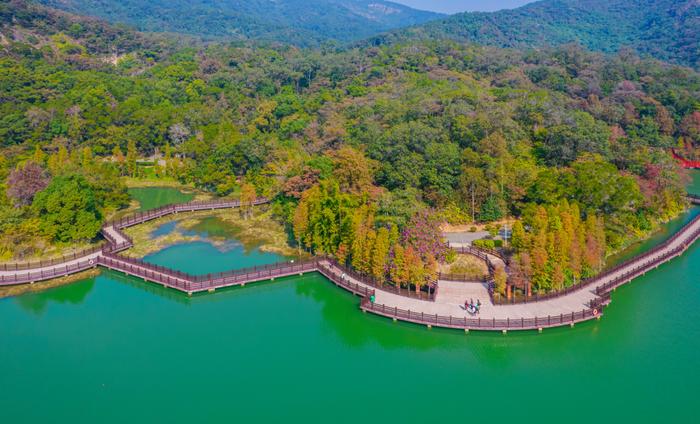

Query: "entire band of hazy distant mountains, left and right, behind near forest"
(41, 0), (700, 69)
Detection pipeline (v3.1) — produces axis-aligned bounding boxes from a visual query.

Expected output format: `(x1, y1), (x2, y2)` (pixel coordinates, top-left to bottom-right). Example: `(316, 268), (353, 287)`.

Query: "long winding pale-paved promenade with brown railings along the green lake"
(0, 198), (700, 331)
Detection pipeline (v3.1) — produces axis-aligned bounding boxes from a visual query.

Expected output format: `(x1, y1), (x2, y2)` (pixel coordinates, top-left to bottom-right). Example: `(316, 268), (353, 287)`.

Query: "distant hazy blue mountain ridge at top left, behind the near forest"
(39, 0), (444, 46)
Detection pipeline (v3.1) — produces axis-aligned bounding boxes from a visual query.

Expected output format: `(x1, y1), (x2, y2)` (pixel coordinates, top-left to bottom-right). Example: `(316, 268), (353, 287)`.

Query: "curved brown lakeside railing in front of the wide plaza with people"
(360, 298), (602, 330)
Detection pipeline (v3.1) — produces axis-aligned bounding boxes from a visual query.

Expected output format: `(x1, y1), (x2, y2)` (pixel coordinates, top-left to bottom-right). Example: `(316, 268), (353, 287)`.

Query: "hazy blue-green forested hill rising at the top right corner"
(374, 0), (700, 69)
